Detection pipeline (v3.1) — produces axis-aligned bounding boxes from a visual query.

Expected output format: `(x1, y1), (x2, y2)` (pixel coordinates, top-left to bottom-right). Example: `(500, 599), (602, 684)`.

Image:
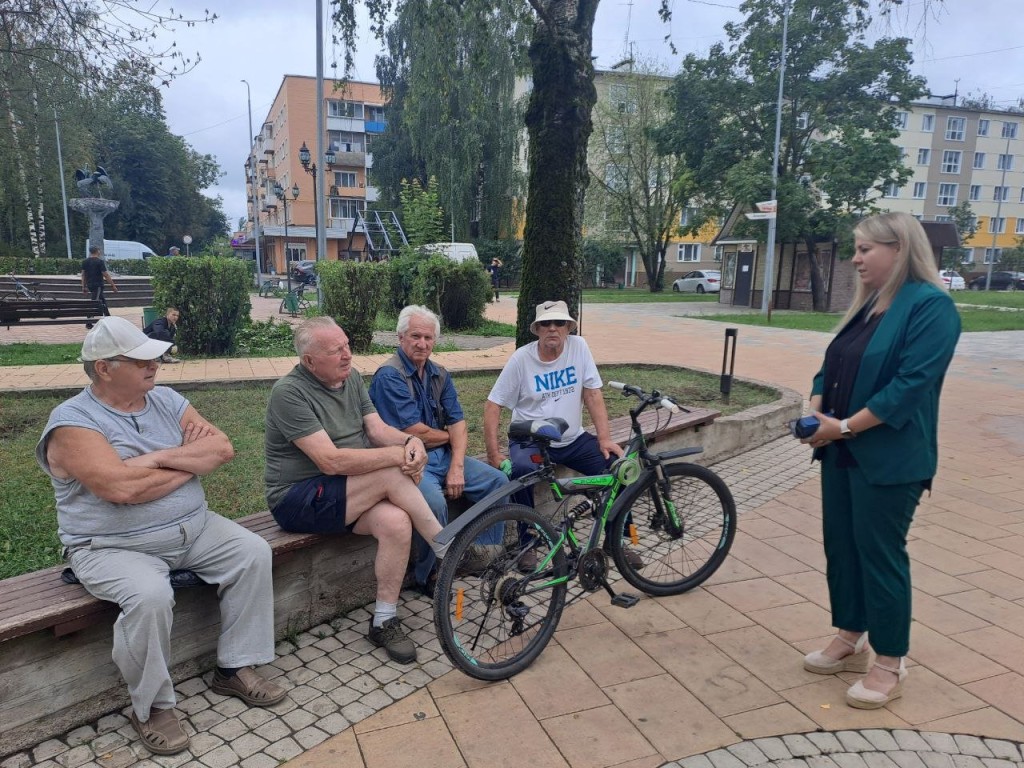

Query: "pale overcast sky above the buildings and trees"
(151, 0), (1024, 228)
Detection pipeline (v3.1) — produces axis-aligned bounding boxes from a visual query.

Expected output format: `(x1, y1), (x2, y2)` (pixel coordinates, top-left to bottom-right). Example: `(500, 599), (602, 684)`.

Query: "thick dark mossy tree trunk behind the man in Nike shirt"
(516, 0), (598, 346)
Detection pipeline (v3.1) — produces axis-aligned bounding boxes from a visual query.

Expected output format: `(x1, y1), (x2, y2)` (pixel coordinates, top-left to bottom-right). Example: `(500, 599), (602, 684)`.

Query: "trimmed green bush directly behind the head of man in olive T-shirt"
(316, 261), (389, 353)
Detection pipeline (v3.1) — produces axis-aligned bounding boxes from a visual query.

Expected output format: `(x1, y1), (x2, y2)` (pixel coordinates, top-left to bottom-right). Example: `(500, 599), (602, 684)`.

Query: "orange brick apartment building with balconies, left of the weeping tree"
(237, 75), (387, 274)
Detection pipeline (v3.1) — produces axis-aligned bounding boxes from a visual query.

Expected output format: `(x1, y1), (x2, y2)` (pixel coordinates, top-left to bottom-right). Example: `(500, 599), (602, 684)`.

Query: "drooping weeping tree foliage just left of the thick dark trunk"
(374, 0), (529, 240)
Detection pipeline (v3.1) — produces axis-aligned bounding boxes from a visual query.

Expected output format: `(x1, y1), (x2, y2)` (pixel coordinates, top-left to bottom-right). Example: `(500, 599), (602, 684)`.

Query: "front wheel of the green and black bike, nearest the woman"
(609, 463), (736, 596)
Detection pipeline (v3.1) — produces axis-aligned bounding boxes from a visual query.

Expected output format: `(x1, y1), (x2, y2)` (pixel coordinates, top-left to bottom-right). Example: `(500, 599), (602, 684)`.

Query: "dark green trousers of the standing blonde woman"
(821, 445), (924, 656)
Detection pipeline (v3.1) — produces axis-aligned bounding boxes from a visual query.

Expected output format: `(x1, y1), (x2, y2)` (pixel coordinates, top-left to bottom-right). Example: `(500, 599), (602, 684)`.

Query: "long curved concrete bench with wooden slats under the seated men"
(0, 409), (719, 758)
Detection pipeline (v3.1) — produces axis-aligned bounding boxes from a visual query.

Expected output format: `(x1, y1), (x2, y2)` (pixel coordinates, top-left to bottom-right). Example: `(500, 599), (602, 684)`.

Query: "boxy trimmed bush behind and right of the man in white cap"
(152, 257), (252, 354)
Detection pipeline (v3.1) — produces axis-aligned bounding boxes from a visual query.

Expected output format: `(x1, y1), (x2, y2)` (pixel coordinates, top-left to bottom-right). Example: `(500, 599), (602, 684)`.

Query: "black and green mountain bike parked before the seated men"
(434, 382), (736, 680)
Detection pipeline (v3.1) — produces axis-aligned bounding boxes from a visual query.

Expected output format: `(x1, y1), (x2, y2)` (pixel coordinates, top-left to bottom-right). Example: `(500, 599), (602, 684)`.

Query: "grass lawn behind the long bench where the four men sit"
(0, 366), (775, 579)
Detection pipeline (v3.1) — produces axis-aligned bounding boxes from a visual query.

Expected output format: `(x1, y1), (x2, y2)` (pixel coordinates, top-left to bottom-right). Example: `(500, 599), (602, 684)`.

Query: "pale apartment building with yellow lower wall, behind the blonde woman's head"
(877, 99), (1024, 274)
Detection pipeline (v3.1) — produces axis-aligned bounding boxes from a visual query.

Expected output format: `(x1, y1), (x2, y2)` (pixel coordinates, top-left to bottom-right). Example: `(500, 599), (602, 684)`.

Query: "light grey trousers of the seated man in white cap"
(69, 510), (274, 722)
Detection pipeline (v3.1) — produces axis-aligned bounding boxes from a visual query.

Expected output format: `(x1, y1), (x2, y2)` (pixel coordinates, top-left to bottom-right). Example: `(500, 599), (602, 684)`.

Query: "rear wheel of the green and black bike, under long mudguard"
(434, 504), (567, 680)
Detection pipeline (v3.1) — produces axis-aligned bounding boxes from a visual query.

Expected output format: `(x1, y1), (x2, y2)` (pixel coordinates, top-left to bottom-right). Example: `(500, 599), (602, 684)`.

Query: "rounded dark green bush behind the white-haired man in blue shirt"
(412, 256), (490, 331)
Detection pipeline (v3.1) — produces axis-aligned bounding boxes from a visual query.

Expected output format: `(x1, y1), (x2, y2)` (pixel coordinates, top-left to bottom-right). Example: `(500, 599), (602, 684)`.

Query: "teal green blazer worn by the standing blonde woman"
(811, 283), (961, 485)
